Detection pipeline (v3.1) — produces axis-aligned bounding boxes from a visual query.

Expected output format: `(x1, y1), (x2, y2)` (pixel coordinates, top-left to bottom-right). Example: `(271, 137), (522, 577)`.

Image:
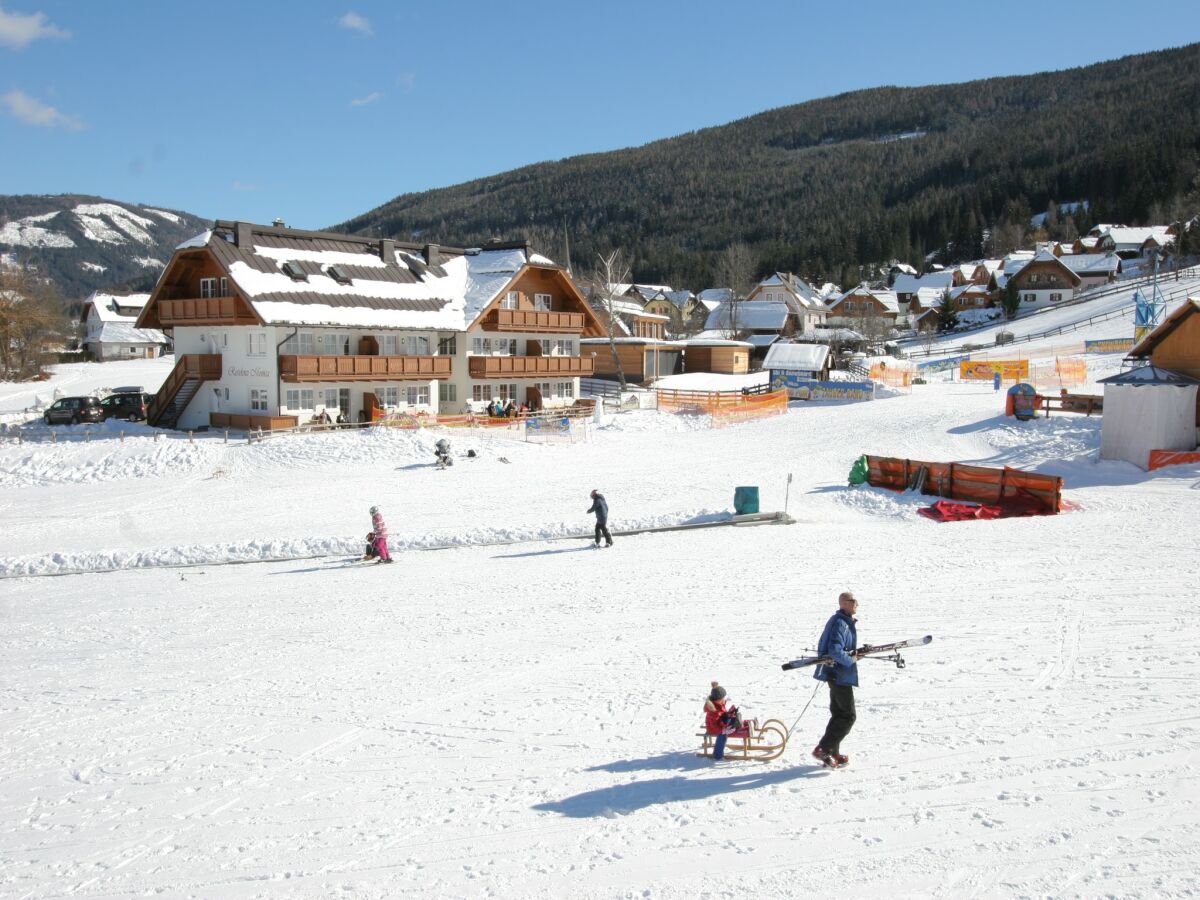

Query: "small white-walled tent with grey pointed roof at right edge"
(1099, 366), (1200, 469)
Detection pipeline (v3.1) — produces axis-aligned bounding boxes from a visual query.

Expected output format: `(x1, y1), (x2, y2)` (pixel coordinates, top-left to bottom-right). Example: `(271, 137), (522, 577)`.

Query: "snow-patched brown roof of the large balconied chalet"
(162, 222), (564, 331)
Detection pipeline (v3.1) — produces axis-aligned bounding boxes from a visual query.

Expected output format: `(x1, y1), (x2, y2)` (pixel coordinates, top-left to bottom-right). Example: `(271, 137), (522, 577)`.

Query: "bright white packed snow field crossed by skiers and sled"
(0, 345), (1200, 898)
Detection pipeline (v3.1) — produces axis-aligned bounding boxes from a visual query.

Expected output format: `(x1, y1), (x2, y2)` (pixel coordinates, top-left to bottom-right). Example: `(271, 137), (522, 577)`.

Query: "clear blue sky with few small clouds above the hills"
(0, 0), (1200, 229)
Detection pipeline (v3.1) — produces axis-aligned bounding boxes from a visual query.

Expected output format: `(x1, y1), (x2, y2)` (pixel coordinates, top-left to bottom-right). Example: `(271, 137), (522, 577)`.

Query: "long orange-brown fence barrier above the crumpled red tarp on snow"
(866, 456), (1062, 512)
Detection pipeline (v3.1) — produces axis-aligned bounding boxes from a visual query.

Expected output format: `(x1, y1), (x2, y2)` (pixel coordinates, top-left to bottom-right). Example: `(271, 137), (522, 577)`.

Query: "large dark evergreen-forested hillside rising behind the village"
(337, 44), (1200, 288)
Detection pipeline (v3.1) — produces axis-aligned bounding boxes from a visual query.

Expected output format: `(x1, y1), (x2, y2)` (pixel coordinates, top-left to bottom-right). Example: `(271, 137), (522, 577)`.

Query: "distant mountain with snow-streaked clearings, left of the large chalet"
(0, 194), (210, 301)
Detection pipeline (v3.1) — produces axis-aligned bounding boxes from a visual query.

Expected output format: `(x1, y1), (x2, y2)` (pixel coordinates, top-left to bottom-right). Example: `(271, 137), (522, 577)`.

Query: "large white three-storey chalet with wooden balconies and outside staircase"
(137, 221), (602, 428)
